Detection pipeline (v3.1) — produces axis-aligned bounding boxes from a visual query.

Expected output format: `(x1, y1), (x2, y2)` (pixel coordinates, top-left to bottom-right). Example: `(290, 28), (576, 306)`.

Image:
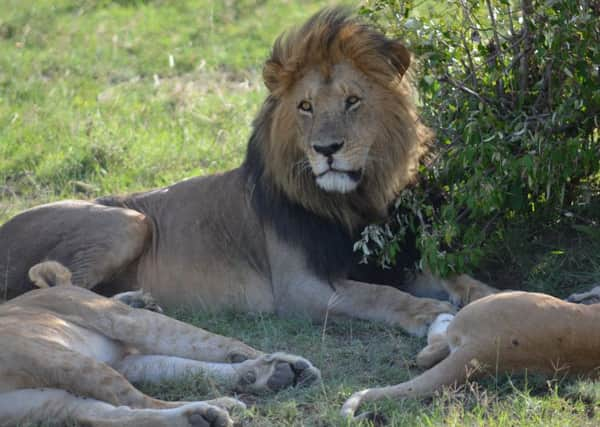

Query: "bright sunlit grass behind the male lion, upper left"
(0, 0), (338, 220)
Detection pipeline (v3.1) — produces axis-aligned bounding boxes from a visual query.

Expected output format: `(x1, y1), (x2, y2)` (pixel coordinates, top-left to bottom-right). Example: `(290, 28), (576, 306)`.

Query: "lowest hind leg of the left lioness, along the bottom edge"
(0, 337), (231, 427)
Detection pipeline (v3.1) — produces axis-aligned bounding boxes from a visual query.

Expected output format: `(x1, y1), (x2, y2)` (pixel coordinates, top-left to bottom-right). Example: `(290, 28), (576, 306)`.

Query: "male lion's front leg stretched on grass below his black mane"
(328, 280), (456, 336)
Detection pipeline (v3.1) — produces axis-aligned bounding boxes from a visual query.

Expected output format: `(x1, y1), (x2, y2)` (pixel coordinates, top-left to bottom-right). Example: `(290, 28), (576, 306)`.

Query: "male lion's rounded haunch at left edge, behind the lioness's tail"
(0, 201), (151, 299)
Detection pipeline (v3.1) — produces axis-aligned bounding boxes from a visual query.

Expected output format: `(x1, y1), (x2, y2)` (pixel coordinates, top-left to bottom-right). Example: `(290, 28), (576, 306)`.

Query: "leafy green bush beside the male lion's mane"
(355, 0), (600, 275)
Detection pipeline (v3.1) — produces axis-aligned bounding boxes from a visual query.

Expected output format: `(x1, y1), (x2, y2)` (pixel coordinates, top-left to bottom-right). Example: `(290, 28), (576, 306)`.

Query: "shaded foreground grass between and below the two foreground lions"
(141, 312), (600, 426)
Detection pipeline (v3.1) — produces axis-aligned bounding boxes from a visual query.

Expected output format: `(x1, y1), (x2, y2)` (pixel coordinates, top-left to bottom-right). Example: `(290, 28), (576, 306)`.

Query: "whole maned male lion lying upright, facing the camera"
(0, 5), (494, 334)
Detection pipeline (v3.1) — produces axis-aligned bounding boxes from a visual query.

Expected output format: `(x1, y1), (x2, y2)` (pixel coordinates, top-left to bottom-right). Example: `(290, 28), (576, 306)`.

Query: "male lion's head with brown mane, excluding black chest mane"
(249, 9), (431, 230)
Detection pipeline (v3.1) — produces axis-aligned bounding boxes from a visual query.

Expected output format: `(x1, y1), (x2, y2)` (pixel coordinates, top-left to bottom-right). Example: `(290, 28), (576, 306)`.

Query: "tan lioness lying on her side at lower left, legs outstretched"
(0, 262), (320, 427)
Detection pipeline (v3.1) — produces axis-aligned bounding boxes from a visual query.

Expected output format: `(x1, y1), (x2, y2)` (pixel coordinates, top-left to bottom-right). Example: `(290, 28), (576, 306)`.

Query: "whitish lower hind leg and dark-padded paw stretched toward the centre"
(116, 353), (321, 393)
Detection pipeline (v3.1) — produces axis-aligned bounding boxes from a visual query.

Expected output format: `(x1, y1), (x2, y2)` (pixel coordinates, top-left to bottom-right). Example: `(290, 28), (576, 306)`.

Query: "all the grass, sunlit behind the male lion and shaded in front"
(0, 0), (600, 426)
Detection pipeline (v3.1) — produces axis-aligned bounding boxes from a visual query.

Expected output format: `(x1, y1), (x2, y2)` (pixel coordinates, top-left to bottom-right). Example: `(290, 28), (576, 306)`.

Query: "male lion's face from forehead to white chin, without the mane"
(286, 62), (376, 193)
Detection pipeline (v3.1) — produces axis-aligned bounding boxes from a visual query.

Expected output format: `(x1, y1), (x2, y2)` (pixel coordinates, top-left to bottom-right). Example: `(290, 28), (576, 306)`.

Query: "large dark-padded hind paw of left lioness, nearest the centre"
(238, 353), (321, 393)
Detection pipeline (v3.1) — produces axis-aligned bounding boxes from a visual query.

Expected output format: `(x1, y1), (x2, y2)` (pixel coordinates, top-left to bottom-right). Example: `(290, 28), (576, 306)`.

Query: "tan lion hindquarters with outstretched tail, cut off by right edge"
(342, 288), (600, 416)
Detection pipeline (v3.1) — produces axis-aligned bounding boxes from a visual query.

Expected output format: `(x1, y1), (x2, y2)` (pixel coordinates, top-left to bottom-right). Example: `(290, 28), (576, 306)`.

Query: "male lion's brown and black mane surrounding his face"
(243, 8), (431, 280)
